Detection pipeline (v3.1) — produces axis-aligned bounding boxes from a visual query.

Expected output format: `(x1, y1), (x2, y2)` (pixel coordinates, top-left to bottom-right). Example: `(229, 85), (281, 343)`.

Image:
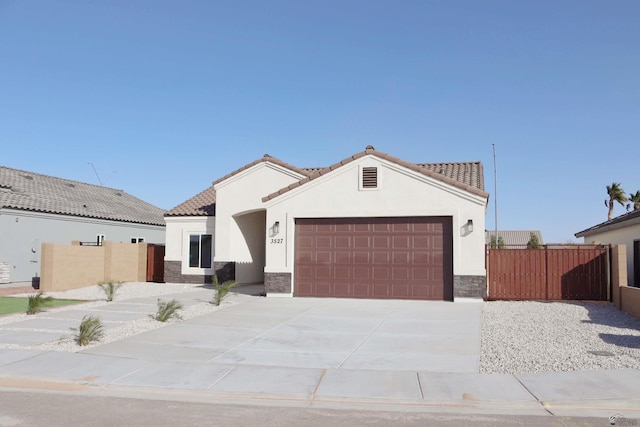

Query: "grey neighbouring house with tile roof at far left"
(0, 166), (165, 283)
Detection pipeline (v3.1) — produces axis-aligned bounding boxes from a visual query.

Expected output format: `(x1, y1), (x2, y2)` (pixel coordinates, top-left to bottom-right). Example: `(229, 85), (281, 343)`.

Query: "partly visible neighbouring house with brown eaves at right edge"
(575, 210), (640, 286)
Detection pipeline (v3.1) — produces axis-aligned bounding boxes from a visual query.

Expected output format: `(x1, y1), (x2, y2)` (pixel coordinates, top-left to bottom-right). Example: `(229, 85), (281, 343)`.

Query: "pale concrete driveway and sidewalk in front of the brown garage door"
(0, 290), (640, 419)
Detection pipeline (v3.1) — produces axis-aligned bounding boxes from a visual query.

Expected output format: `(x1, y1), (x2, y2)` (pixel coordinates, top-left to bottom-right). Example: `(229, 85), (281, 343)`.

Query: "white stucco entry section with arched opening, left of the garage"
(214, 162), (303, 283)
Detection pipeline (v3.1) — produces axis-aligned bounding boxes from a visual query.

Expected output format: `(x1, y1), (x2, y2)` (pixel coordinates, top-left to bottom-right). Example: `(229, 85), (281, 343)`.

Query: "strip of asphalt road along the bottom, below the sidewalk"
(0, 390), (616, 427)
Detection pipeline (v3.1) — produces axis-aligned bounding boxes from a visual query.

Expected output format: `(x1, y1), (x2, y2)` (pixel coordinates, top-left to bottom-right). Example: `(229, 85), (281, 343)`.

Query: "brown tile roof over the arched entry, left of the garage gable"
(165, 154), (311, 216)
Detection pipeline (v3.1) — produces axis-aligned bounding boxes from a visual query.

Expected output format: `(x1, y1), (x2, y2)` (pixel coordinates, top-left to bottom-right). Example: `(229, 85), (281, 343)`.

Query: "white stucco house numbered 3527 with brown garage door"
(165, 146), (489, 300)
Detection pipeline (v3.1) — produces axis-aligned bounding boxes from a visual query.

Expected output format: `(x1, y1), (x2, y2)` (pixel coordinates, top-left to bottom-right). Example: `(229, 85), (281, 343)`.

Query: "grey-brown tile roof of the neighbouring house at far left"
(0, 166), (165, 226)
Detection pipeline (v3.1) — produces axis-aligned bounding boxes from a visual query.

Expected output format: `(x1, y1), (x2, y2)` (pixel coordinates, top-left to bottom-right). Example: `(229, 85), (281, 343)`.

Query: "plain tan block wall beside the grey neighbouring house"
(40, 242), (147, 292)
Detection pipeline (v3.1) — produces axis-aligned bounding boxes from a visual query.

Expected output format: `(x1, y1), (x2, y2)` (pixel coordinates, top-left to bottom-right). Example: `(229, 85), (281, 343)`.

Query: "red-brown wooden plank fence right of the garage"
(486, 245), (610, 301)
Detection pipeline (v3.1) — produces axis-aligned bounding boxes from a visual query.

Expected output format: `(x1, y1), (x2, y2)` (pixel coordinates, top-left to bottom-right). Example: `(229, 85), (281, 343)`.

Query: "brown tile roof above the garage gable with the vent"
(262, 145), (489, 202)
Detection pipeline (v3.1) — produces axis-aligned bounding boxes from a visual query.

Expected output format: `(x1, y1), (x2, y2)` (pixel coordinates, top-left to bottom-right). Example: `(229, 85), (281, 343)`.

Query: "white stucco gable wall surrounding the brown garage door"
(265, 156), (487, 294)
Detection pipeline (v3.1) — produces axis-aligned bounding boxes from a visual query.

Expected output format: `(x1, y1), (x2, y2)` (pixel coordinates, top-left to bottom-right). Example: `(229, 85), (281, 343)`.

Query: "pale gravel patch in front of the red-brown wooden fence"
(480, 301), (640, 373)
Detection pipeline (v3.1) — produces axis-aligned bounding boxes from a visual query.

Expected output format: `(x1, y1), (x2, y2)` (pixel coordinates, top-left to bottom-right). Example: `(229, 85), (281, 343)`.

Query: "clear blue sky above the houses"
(0, 0), (640, 242)
